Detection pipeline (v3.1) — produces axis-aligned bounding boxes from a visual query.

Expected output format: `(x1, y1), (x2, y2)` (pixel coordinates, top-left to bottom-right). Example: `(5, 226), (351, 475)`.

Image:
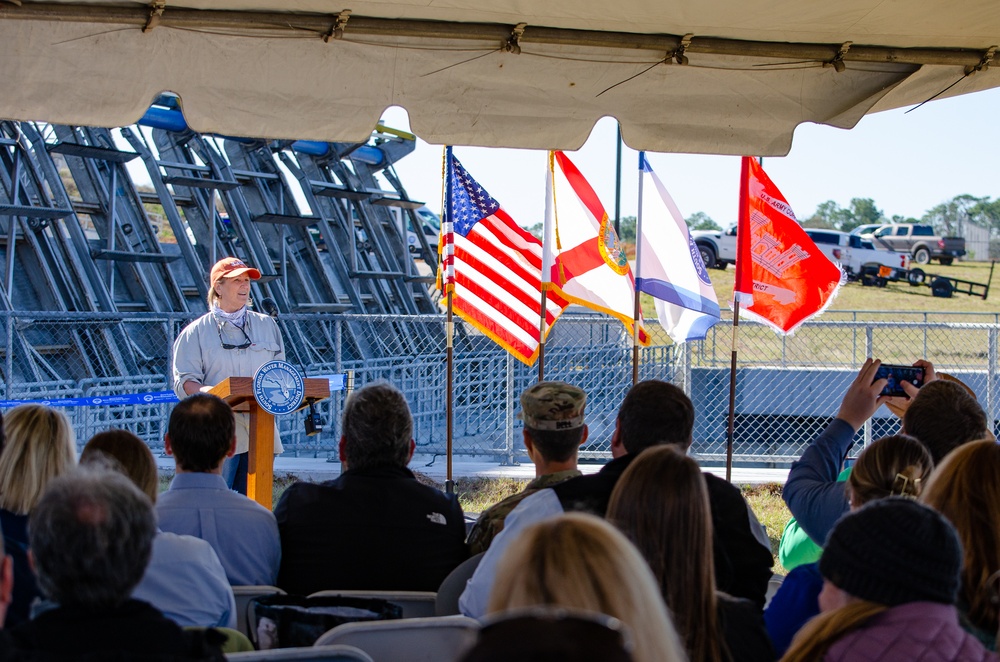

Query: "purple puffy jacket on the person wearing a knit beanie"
(823, 602), (1000, 662)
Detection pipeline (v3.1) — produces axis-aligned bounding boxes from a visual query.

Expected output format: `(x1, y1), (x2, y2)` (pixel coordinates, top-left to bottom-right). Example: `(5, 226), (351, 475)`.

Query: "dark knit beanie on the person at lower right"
(819, 497), (962, 607)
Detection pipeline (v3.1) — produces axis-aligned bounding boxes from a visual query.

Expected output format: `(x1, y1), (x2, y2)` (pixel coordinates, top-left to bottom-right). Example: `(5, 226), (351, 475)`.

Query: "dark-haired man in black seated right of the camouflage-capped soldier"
(459, 380), (774, 618)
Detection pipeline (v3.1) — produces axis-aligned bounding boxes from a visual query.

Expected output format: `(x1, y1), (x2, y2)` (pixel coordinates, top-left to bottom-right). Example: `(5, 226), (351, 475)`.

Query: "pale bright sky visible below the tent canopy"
(383, 89), (1000, 227)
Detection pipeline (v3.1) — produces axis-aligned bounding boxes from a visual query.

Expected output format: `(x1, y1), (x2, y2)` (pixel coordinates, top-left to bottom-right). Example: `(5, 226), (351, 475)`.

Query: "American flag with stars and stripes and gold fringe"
(441, 147), (567, 365)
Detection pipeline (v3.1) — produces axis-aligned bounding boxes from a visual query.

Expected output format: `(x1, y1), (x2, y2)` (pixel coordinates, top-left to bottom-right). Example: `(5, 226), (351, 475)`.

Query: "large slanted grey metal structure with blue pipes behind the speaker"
(0, 105), (444, 391)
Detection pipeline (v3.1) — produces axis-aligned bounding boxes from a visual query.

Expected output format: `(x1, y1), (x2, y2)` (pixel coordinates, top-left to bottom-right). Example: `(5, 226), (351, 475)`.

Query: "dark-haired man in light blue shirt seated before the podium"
(156, 393), (281, 586)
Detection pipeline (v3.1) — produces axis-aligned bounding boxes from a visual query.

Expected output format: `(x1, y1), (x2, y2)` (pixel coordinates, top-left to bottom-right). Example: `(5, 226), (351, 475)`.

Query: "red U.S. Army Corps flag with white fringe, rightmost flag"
(733, 156), (843, 334)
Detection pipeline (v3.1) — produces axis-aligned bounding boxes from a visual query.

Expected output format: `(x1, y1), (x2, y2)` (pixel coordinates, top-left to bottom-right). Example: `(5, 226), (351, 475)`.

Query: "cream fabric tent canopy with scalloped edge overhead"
(0, 0), (1000, 156)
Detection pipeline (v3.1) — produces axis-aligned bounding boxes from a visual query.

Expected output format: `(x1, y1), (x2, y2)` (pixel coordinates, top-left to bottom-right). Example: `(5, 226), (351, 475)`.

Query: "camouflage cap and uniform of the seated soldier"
(469, 382), (587, 554)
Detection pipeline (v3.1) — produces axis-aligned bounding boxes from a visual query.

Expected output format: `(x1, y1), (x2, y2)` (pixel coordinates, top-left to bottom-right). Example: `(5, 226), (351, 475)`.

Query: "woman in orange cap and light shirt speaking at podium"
(173, 257), (285, 494)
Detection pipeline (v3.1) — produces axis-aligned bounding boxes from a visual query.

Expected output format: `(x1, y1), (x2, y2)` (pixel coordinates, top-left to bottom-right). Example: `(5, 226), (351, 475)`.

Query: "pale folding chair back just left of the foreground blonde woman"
(316, 616), (479, 662)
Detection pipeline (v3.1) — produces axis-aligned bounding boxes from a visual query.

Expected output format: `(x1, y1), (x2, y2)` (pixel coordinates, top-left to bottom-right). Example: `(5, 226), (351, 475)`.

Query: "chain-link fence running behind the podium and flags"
(0, 312), (1000, 463)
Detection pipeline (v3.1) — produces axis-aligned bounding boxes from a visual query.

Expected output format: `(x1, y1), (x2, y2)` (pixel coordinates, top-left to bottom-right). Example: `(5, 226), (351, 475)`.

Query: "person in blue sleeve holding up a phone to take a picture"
(782, 359), (988, 544)
